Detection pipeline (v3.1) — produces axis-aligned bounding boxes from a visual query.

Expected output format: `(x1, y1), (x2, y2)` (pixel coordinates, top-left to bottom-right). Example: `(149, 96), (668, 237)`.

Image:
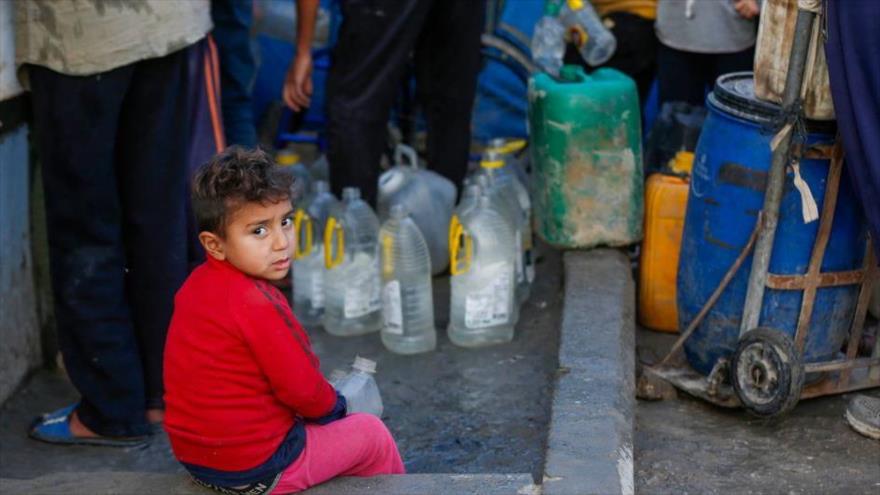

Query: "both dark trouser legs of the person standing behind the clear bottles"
(327, 0), (486, 204)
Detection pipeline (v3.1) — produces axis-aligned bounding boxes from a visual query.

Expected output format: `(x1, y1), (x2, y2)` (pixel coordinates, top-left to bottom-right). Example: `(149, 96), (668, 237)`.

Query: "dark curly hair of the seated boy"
(192, 146), (294, 237)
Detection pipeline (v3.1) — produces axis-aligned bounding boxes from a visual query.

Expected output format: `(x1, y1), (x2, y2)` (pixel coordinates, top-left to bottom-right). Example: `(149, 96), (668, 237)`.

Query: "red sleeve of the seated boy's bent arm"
(230, 281), (336, 418)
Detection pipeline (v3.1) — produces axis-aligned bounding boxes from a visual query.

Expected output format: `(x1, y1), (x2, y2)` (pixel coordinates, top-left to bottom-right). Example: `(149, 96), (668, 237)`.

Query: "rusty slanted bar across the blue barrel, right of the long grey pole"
(794, 139), (843, 355)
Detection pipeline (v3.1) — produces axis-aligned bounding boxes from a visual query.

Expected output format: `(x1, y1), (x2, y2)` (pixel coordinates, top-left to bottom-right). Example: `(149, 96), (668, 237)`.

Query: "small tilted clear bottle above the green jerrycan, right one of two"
(562, 0), (617, 67)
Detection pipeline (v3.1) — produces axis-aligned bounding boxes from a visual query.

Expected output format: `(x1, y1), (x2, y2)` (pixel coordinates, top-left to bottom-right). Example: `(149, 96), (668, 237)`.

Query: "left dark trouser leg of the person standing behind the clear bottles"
(327, 0), (429, 205)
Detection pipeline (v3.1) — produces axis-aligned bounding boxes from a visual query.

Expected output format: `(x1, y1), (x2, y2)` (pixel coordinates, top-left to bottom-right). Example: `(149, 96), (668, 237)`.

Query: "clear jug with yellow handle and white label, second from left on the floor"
(323, 187), (382, 336)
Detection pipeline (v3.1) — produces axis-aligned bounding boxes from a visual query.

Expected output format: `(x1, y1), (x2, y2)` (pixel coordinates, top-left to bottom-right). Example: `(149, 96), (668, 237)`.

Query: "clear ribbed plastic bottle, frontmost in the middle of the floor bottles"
(379, 205), (437, 354)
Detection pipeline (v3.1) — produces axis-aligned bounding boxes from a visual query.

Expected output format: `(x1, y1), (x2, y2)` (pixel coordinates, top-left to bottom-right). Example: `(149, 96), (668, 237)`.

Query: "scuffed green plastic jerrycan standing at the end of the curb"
(528, 65), (644, 248)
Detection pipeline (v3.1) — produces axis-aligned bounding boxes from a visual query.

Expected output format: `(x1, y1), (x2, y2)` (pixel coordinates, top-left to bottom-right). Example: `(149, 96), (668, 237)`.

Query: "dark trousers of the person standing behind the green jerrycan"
(564, 12), (659, 105)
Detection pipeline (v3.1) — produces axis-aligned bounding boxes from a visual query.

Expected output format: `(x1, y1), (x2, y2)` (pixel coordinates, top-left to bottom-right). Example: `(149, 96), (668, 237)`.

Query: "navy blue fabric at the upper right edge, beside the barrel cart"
(825, 0), (880, 259)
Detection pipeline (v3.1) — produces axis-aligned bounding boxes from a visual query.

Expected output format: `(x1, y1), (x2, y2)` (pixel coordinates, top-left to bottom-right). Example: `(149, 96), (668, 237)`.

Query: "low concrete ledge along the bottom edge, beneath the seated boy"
(0, 471), (540, 495)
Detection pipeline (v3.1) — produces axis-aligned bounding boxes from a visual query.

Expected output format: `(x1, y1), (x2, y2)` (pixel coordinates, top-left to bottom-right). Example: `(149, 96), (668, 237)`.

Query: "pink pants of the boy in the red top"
(272, 414), (406, 494)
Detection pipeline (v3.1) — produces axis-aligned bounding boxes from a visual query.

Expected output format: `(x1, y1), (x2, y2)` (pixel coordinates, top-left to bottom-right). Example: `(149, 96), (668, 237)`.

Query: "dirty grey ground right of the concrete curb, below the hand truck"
(635, 330), (880, 494)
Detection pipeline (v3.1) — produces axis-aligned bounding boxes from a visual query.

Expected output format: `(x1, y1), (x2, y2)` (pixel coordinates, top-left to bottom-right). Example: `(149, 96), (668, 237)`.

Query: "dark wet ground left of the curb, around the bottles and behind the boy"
(0, 249), (562, 479)
